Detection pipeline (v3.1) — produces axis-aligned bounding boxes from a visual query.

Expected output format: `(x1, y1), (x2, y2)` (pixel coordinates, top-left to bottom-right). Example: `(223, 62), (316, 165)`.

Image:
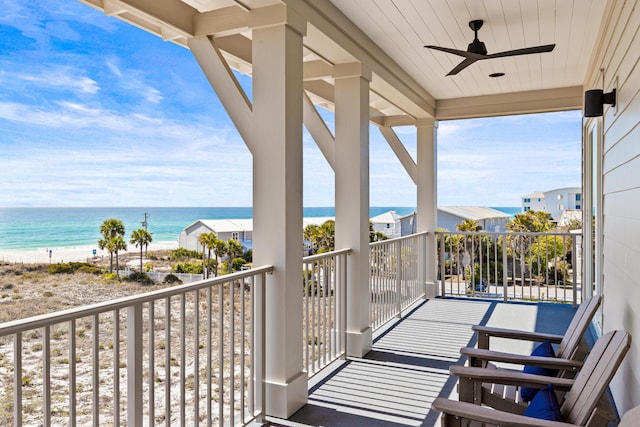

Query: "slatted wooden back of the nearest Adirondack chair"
(560, 331), (631, 425)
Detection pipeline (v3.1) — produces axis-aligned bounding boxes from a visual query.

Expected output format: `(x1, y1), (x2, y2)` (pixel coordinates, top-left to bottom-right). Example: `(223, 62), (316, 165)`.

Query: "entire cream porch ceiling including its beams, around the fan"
(80, 0), (618, 125)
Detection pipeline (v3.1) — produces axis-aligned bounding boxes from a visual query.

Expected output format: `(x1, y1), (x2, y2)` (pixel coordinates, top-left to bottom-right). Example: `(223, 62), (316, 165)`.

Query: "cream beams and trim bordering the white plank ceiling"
(80, 0), (583, 126)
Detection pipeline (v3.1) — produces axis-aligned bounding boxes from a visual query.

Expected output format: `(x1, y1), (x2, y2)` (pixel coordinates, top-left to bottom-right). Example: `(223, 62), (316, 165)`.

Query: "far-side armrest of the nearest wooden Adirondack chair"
(449, 365), (574, 391)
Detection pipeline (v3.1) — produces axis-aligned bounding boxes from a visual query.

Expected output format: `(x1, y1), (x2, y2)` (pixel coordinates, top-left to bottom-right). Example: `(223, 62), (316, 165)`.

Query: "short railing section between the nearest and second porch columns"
(302, 249), (351, 376)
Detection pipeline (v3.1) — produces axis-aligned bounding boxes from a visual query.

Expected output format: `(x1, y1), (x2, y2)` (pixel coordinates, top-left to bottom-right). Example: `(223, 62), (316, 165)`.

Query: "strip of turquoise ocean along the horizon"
(0, 207), (415, 251)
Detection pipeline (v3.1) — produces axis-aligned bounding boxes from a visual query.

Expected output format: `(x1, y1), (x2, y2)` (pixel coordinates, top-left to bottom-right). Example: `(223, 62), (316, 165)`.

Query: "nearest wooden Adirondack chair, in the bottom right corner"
(432, 331), (631, 427)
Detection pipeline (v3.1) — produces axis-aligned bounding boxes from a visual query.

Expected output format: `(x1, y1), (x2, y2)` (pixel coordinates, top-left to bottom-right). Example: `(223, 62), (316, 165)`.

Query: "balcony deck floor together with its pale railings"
(0, 233), (592, 425)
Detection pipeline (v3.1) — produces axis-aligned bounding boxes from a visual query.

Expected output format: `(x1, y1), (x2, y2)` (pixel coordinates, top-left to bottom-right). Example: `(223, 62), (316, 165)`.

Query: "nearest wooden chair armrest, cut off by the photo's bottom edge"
(431, 397), (576, 427)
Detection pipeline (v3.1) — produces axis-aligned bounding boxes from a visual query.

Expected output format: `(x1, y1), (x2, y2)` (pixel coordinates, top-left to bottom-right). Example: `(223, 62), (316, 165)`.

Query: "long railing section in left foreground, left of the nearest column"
(0, 266), (272, 426)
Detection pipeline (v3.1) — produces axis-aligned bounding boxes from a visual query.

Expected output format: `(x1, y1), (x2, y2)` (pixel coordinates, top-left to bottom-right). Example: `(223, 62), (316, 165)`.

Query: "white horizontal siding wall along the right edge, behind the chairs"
(585, 0), (640, 413)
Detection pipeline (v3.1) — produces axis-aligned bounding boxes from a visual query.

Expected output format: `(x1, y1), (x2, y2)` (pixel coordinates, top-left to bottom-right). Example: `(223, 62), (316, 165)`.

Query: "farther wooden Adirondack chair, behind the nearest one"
(458, 296), (613, 416)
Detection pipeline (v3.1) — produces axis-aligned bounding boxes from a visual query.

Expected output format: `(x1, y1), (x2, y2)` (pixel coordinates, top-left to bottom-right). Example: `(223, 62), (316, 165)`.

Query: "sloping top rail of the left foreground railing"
(0, 265), (273, 337)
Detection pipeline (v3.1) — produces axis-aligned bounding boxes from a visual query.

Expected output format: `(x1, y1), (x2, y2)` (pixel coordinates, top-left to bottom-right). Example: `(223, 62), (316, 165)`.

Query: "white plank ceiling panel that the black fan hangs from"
(331, 0), (606, 99)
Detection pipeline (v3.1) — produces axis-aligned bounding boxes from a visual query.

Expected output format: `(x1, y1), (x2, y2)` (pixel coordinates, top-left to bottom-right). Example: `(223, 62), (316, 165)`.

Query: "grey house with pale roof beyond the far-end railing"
(438, 206), (510, 232)
